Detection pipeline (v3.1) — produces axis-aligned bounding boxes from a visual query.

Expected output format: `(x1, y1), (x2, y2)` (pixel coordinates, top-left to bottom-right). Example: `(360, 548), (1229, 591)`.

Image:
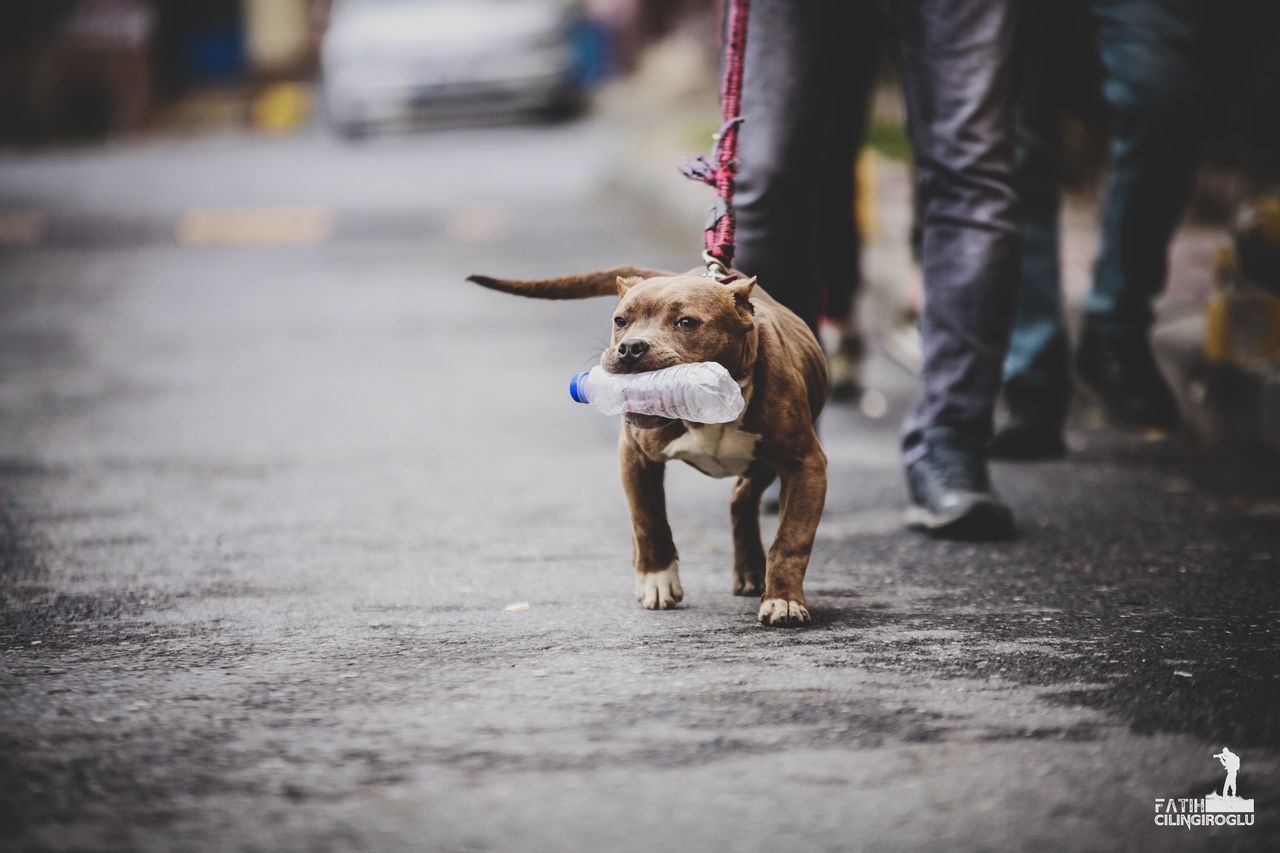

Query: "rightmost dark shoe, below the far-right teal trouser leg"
(1075, 323), (1179, 429)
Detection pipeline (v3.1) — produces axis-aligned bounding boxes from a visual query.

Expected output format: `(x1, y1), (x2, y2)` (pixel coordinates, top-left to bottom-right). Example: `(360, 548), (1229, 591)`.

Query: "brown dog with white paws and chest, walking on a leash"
(468, 268), (827, 625)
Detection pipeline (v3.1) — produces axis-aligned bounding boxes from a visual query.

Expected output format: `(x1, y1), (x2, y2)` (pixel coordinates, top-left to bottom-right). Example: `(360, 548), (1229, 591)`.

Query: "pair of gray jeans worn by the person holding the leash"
(735, 0), (1020, 462)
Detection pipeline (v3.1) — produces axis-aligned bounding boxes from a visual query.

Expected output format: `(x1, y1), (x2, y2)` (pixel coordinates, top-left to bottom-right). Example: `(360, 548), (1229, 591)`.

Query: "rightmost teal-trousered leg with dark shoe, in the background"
(1076, 0), (1204, 427)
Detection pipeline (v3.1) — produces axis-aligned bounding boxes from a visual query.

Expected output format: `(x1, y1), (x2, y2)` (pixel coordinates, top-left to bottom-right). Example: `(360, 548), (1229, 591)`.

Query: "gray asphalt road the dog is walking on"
(0, 116), (1280, 852)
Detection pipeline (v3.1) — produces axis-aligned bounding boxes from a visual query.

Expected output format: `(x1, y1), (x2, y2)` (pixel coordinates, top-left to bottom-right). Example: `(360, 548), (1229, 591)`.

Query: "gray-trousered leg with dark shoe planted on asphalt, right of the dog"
(895, 0), (1020, 537)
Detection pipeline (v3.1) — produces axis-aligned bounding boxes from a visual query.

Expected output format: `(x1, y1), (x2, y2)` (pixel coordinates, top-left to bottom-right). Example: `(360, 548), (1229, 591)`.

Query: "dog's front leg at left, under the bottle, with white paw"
(618, 428), (685, 610)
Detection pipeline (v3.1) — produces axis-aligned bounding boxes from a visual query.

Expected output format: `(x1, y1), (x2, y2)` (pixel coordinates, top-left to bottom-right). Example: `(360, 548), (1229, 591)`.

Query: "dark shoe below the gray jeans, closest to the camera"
(906, 427), (1014, 539)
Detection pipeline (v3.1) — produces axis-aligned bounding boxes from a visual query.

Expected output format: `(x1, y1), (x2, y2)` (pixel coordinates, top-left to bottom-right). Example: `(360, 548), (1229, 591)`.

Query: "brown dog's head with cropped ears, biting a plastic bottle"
(600, 275), (756, 427)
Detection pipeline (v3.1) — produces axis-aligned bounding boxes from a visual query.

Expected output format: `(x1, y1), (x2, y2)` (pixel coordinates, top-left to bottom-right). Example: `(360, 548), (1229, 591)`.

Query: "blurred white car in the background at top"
(321, 0), (585, 136)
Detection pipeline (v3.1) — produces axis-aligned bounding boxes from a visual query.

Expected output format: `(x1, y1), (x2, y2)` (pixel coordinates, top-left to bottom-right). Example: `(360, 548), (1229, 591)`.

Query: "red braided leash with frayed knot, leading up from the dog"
(681, 0), (750, 280)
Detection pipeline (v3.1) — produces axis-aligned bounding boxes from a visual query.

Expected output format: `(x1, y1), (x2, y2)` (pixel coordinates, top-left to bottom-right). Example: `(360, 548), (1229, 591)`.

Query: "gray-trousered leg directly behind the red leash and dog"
(733, 0), (865, 329)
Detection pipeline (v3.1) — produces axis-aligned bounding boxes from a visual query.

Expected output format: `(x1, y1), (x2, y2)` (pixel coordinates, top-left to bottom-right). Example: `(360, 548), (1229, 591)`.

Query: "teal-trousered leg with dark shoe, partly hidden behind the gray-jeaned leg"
(991, 0), (1071, 459)
